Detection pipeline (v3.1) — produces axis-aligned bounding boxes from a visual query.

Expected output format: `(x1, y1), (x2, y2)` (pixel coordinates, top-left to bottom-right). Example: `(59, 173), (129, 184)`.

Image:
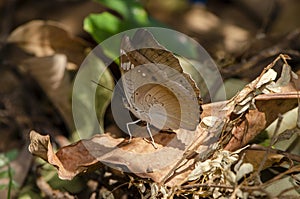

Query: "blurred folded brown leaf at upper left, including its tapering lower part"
(7, 20), (89, 131)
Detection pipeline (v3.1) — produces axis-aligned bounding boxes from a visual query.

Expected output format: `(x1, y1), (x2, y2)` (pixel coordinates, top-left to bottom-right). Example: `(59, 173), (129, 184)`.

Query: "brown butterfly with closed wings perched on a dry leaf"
(121, 29), (202, 147)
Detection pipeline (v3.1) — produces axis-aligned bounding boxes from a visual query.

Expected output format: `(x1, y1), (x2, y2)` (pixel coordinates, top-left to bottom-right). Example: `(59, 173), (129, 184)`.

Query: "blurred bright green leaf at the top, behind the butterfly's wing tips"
(83, 0), (164, 43)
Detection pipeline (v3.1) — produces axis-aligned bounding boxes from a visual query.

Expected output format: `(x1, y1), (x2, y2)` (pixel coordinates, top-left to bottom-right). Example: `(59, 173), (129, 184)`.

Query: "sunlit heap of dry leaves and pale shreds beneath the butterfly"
(29, 55), (299, 198)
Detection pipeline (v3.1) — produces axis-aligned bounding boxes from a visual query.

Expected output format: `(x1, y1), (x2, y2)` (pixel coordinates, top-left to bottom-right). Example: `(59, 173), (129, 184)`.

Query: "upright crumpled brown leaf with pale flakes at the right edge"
(225, 55), (299, 151)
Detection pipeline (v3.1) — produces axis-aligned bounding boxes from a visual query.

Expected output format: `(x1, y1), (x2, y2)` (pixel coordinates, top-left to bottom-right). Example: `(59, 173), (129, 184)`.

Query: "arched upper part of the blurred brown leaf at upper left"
(7, 20), (89, 67)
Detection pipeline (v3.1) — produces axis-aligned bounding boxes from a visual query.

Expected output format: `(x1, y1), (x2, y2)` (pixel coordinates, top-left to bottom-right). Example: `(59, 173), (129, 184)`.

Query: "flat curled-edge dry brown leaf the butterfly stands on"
(29, 109), (218, 186)
